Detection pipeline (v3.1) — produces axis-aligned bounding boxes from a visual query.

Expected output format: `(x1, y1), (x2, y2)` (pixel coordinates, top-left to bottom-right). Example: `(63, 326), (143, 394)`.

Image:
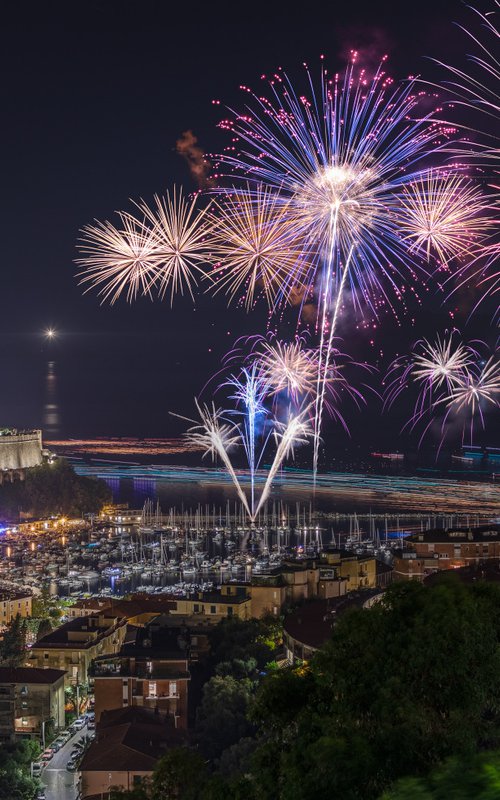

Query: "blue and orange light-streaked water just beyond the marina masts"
(68, 461), (500, 514)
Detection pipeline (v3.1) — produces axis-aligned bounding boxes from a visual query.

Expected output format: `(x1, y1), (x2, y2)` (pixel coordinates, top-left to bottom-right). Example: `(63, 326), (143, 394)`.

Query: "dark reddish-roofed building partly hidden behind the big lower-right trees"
(283, 589), (382, 664)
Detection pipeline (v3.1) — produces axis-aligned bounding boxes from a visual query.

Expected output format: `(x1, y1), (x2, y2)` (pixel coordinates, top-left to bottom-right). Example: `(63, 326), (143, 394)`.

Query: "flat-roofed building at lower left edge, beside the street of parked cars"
(0, 667), (65, 743)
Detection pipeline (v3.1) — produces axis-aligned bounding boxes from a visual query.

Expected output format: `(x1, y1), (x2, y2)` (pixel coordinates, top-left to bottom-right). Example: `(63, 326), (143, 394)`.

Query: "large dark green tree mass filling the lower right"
(252, 581), (500, 800)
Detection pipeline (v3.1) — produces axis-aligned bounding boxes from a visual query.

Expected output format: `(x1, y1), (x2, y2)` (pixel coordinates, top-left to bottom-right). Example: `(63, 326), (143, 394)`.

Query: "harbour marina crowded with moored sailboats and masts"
(0, 499), (493, 598)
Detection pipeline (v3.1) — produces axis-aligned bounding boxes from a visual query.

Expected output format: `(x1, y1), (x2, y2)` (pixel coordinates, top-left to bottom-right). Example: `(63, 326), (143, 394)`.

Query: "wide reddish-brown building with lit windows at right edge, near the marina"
(393, 525), (500, 581)
